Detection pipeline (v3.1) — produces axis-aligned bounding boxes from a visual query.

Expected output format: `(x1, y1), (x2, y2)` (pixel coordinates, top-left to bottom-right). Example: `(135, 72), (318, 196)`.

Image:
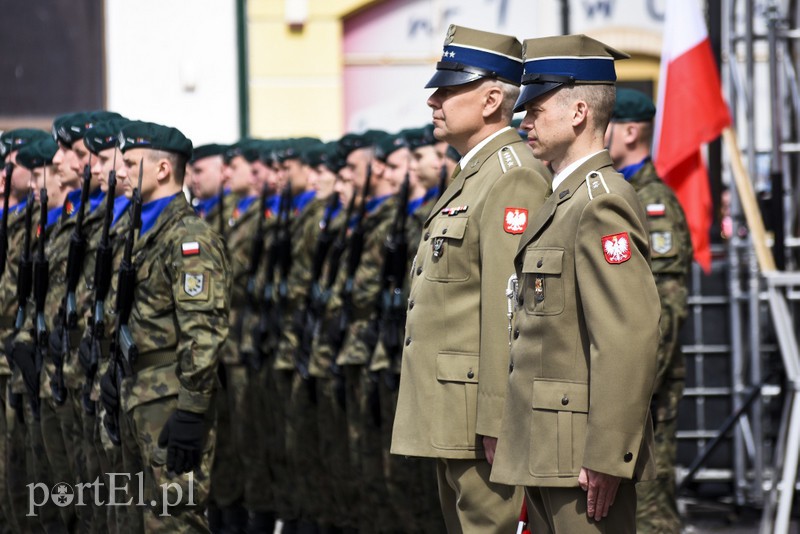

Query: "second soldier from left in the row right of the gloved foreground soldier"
(208, 141), (263, 532)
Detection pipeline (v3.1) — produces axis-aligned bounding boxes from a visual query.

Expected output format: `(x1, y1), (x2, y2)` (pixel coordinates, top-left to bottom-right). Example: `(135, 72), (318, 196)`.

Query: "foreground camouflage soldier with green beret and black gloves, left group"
(101, 121), (231, 532)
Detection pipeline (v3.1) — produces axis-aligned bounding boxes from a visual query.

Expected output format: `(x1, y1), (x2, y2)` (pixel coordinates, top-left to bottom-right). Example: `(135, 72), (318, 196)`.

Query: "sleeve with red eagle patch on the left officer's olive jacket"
(475, 167), (549, 437)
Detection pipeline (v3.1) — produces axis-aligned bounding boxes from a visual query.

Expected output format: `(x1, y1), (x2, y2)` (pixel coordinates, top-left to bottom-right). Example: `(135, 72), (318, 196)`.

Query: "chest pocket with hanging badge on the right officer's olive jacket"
(520, 248), (564, 315)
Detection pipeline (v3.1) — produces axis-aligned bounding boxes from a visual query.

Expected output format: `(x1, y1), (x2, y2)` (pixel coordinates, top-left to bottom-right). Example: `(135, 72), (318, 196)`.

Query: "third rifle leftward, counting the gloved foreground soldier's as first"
(50, 163), (92, 405)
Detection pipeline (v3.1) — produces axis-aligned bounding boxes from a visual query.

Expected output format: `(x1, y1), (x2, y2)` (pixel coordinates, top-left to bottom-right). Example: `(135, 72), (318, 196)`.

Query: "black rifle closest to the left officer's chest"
(377, 173), (410, 390)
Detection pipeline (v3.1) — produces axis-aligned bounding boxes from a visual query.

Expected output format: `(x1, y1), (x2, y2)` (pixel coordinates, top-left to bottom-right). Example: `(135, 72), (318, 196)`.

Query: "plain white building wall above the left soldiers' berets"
(105, 0), (239, 145)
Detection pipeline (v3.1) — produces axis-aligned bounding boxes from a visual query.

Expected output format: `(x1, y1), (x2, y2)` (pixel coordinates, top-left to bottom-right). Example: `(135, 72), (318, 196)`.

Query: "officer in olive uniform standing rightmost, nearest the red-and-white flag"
(492, 35), (661, 534)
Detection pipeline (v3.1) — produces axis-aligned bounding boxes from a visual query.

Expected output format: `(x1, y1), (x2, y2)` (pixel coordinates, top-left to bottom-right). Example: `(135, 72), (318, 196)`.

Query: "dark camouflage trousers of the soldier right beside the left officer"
(378, 371), (447, 534)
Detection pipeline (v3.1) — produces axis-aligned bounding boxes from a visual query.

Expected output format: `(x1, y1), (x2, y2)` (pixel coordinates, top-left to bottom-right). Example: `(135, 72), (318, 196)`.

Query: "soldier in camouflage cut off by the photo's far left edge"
(0, 129), (53, 531)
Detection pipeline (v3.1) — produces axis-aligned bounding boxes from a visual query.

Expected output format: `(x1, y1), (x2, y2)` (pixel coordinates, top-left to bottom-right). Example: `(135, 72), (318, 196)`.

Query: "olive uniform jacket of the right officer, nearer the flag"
(491, 151), (660, 487)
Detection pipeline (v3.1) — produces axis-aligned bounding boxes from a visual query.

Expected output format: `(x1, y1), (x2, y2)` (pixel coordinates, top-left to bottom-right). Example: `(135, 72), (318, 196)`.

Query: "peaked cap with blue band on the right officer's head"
(514, 35), (630, 112)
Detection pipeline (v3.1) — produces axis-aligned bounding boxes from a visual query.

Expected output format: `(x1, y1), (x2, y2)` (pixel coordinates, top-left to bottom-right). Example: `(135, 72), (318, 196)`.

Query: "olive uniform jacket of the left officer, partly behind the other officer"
(391, 129), (549, 459)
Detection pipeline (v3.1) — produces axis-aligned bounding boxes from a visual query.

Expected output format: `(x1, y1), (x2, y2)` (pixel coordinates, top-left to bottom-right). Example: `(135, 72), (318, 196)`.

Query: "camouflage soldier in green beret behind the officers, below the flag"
(606, 88), (692, 534)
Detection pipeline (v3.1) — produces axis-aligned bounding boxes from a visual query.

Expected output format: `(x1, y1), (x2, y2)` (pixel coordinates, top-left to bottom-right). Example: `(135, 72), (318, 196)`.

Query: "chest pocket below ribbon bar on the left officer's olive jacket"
(424, 217), (470, 282)
